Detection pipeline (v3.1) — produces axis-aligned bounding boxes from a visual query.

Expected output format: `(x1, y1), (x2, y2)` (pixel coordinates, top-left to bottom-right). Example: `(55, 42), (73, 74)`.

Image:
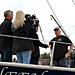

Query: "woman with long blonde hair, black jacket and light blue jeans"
(13, 11), (34, 64)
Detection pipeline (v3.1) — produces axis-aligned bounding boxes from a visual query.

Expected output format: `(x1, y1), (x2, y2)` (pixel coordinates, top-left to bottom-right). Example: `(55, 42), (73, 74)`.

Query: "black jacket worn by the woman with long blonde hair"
(13, 23), (35, 53)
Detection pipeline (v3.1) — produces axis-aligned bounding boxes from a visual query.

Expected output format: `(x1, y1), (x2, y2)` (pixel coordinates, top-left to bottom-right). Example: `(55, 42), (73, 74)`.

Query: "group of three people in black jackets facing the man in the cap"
(0, 10), (50, 64)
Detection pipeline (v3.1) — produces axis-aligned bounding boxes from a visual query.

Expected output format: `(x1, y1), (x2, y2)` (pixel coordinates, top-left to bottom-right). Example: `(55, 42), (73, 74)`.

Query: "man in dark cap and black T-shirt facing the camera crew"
(49, 27), (74, 67)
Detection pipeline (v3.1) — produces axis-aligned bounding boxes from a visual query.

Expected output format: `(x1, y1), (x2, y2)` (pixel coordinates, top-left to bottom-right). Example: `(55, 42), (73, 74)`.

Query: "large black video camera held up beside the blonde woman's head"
(25, 14), (39, 28)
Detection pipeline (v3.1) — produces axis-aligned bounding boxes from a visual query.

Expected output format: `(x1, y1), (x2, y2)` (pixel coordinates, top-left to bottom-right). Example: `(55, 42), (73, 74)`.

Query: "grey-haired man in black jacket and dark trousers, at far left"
(1, 10), (13, 62)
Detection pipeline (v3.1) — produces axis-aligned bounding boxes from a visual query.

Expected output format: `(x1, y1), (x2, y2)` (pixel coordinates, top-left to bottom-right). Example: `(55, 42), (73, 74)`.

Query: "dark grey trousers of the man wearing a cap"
(53, 58), (68, 67)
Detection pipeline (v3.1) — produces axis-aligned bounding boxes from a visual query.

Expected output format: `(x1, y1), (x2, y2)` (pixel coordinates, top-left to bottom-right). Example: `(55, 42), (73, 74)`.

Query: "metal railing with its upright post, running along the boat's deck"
(0, 34), (72, 67)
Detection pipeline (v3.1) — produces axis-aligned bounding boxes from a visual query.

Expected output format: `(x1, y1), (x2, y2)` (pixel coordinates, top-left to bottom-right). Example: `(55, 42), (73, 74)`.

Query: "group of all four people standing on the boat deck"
(0, 10), (74, 67)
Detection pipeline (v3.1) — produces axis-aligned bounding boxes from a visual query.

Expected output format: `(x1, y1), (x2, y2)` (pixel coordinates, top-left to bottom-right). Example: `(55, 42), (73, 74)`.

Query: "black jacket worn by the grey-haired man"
(1, 19), (13, 50)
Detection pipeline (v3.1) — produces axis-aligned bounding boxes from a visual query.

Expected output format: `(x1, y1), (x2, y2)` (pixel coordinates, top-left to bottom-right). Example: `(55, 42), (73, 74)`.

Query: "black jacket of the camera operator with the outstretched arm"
(31, 33), (48, 58)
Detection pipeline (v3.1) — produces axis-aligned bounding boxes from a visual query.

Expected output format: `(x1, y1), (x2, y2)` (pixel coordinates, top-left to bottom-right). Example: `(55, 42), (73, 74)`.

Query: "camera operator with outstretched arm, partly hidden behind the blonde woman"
(30, 20), (50, 65)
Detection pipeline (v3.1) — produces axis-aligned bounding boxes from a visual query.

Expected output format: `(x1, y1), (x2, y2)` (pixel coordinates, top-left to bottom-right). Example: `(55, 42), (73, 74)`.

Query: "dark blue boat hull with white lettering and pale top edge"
(0, 63), (75, 75)
